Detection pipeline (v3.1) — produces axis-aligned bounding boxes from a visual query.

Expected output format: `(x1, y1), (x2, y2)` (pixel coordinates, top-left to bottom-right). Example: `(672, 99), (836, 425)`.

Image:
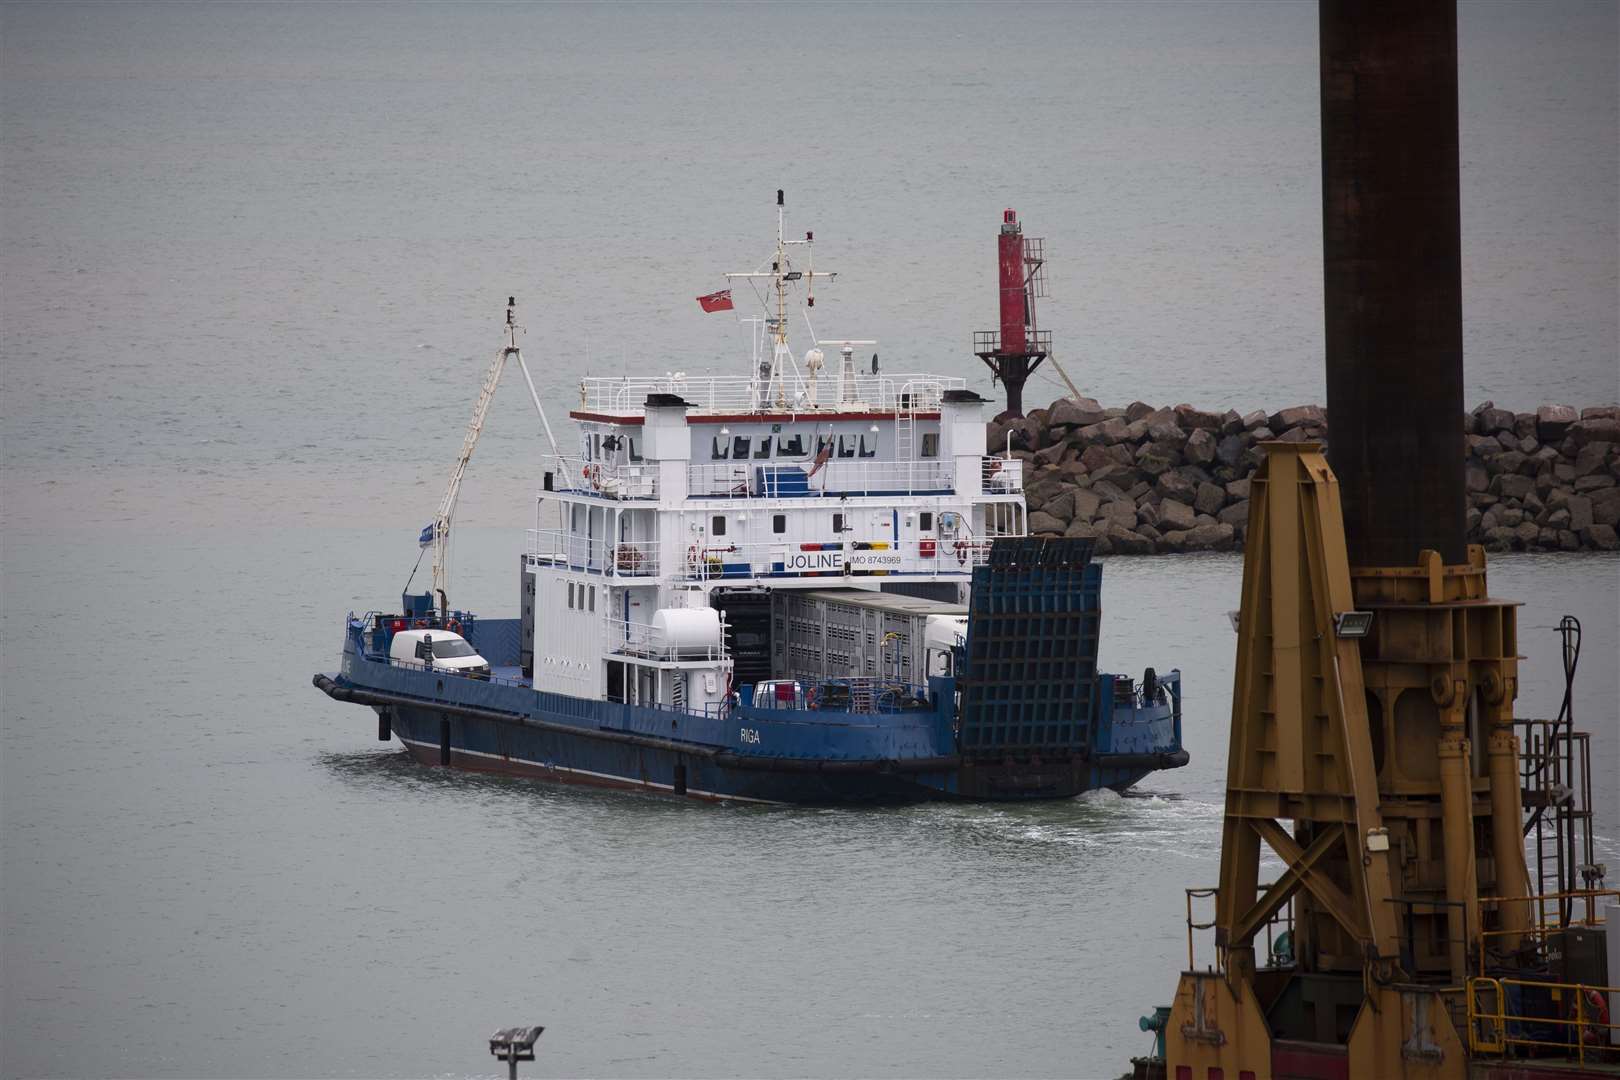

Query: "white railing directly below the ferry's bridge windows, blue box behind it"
(687, 458), (952, 499)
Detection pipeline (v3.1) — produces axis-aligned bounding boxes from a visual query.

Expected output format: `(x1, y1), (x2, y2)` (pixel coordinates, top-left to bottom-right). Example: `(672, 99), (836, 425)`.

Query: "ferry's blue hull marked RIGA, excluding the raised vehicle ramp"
(314, 622), (1186, 803)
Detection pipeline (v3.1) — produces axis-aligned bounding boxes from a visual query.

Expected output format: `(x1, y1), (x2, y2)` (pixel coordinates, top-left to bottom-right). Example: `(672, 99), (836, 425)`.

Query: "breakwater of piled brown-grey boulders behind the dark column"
(988, 398), (1620, 555)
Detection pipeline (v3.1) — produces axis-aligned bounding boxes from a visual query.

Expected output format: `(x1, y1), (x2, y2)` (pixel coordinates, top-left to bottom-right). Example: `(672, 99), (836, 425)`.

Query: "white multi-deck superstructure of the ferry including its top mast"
(522, 196), (1025, 711)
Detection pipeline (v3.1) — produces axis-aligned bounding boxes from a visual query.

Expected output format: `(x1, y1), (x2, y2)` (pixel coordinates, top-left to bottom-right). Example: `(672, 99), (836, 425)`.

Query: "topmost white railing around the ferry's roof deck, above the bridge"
(578, 372), (967, 415)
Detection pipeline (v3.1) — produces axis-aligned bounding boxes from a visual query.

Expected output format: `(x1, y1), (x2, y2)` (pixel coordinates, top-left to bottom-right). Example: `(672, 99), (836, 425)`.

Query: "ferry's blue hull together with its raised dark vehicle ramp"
(314, 541), (1187, 803)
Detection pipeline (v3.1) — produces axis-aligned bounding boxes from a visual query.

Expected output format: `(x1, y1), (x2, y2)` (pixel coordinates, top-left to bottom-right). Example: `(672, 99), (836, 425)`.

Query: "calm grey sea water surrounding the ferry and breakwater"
(0, 3), (1620, 1077)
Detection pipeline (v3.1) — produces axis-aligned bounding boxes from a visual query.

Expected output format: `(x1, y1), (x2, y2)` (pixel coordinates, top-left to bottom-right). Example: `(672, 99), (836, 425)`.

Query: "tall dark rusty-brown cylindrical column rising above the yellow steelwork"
(1320, 0), (1468, 567)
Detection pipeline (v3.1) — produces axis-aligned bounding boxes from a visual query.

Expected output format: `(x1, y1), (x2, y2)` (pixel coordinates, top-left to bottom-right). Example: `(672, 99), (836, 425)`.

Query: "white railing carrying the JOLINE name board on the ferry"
(671, 539), (990, 581)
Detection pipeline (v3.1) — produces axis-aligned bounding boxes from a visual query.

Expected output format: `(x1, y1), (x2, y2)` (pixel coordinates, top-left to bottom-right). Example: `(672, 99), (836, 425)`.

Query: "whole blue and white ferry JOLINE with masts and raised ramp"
(314, 191), (1187, 803)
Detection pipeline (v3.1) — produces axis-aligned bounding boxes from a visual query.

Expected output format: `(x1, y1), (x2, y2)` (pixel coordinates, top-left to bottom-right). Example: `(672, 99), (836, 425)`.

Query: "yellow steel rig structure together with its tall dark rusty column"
(1139, 0), (1620, 1080)
